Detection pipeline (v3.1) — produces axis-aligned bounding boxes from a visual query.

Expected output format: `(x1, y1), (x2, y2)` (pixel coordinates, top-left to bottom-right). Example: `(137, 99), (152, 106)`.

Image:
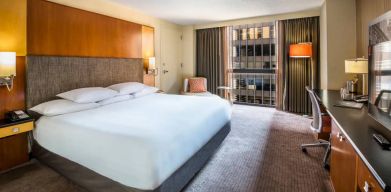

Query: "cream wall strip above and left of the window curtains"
(182, 9), (320, 77)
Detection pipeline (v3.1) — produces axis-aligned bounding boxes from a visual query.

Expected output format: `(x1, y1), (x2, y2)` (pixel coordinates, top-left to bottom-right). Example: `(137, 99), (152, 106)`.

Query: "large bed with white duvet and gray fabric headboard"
(27, 56), (231, 191)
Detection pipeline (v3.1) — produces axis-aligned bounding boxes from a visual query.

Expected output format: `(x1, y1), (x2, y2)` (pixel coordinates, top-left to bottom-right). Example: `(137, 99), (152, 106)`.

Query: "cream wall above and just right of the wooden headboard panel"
(48, 0), (182, 87)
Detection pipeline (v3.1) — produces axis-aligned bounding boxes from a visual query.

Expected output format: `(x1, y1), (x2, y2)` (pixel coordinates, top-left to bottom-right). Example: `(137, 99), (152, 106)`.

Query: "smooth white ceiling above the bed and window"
(110, 0), (324, 25)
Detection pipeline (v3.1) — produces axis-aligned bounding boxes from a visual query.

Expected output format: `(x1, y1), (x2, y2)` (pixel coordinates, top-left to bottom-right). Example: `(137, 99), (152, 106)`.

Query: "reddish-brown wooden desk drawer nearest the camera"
(357, 158), (383, 192)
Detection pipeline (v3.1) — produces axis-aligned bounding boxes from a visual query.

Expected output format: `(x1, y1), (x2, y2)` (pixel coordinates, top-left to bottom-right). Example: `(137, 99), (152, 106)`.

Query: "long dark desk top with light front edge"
(314, 90), (391, 191)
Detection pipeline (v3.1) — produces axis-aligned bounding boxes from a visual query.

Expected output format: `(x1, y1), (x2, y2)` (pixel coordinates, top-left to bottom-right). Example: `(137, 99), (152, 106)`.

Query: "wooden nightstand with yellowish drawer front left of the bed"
(0, 119), (34, 171)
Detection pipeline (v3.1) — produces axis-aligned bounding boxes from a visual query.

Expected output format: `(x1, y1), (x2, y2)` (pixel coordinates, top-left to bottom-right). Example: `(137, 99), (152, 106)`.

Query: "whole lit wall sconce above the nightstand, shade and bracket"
(0, 52), (16, 91)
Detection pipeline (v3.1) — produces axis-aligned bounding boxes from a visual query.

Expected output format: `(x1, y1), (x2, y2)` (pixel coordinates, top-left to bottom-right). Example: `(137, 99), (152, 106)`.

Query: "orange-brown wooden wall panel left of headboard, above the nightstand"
(0, 56), (26, 119)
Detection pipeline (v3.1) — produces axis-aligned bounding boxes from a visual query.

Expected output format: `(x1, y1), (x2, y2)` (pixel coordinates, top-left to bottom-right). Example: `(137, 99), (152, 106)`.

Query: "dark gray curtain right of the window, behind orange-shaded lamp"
(276, 17), (319, 114)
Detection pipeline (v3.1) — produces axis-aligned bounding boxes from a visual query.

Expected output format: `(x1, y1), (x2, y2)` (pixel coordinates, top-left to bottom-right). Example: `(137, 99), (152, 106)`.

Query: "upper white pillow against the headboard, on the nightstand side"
(57, 87), (118, 103)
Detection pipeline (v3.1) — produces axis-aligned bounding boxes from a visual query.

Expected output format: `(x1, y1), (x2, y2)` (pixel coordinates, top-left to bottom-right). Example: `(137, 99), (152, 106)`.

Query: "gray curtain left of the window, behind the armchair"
(196, 27), (228, 94)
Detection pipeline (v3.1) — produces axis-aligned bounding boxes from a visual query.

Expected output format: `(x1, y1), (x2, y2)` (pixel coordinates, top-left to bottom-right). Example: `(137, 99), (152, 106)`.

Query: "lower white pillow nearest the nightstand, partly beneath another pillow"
(30, 99), (99, 116)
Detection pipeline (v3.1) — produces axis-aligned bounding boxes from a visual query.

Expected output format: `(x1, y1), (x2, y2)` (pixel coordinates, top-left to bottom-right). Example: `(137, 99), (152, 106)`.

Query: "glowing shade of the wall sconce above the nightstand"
(0, 52), (16, 77)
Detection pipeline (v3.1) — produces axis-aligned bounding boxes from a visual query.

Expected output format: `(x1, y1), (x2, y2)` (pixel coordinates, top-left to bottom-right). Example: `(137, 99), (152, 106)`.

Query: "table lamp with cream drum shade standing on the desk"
(345, 58), (368, 95)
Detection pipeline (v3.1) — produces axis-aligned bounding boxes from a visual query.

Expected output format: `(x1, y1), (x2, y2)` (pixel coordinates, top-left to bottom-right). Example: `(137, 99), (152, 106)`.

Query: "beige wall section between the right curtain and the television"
(321, 0), (357, 90)
